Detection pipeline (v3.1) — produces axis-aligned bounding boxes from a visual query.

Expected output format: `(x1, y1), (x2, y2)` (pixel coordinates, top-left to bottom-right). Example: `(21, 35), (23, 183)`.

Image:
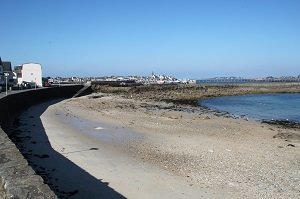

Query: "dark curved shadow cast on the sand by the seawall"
(7, 99), (125, 198)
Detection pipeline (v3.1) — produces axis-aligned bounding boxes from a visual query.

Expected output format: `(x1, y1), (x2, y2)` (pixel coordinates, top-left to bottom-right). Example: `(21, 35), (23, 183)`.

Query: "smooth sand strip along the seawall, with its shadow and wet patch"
(14, 100), (231, 198)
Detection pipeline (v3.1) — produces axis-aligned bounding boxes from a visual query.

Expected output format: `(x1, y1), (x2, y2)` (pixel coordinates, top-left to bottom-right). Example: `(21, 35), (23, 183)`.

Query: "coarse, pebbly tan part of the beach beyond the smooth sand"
(56, 93), (300, 198)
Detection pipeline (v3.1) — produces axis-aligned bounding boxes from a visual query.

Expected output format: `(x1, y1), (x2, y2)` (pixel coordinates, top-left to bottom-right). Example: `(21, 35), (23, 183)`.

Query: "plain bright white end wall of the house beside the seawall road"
(22, 63), (43, 87)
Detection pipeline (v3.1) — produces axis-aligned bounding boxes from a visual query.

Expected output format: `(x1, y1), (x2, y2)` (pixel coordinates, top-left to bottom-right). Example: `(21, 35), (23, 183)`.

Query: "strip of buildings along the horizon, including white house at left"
(0, 57), (300, 92)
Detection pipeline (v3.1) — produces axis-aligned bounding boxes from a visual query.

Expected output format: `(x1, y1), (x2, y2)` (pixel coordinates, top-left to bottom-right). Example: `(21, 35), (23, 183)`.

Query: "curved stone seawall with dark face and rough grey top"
(0, 85), (83, 199)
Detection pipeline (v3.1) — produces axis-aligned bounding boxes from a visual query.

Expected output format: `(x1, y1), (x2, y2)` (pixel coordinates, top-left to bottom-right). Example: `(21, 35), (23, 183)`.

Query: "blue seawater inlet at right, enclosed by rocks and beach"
(199, 94), (300, 122)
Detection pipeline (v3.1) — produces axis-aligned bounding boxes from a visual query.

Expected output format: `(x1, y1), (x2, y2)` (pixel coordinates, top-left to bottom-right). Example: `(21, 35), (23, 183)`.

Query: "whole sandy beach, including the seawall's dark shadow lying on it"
(10, 93), (300, 198)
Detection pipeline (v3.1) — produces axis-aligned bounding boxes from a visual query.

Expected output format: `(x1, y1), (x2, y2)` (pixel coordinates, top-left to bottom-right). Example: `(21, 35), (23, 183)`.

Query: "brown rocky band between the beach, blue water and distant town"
(92, 83), (300, 105)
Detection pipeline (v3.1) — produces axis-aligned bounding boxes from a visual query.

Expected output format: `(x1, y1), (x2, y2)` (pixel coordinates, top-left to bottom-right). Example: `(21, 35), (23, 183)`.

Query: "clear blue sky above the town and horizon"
(0, 0), (300, 79)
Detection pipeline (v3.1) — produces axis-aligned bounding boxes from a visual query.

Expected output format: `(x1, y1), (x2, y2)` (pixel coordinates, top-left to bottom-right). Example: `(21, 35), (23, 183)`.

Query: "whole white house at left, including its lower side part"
(15, 63), (43, 87)
